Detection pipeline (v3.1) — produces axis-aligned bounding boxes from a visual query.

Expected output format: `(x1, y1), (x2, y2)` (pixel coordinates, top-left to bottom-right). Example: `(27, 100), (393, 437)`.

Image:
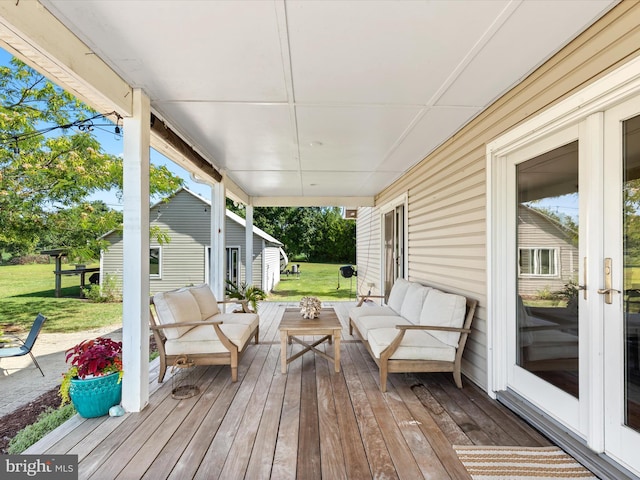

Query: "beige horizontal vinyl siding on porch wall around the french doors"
(357, 2), (640, 387)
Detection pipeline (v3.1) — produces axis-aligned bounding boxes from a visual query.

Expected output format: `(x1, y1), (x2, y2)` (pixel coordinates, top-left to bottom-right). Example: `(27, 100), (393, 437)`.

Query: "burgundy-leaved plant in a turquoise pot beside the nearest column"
(60, 337), (123, 418)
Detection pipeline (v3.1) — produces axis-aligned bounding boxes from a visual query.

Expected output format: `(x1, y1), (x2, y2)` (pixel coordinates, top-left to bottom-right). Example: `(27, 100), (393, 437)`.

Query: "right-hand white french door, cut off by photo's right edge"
(601, 97), (640, 471)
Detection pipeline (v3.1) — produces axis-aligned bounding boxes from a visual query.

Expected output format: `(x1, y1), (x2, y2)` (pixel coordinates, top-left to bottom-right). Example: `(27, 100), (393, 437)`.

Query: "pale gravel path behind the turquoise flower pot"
(0, 324), (122, 417)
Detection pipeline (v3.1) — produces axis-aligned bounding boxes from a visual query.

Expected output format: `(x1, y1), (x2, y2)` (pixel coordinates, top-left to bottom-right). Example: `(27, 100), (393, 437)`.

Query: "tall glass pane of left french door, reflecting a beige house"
(516, 141), (579, 397)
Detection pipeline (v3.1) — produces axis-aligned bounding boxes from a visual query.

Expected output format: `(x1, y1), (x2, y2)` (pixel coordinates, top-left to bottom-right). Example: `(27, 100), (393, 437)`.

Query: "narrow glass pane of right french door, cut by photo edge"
(623, 116), (640, 431)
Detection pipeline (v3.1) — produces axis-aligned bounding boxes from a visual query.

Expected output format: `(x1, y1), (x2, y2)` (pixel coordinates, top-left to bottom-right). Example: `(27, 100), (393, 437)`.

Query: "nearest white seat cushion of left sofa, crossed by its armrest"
(164, 324), (251, 355)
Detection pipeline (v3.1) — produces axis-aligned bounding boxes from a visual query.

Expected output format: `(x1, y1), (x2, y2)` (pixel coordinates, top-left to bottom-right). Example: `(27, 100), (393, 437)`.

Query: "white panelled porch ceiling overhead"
(41, 0), (617, 206)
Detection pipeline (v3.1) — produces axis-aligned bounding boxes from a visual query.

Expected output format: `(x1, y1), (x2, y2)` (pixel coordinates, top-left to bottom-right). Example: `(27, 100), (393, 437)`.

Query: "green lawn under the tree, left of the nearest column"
(0, 263), (122, 333)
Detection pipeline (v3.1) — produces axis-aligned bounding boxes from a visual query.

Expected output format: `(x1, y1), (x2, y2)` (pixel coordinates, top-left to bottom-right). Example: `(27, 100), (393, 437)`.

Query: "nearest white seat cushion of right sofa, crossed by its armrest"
(368, 328), (456, 362)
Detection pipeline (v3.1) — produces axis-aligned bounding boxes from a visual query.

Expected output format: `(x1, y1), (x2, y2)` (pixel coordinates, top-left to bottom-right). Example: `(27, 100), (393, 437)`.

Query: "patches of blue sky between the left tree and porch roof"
(0, 48), (211, 210)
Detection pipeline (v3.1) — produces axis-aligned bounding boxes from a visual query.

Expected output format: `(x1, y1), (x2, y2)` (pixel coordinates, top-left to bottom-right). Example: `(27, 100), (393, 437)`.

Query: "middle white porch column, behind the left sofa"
(209, 182), (227, 300)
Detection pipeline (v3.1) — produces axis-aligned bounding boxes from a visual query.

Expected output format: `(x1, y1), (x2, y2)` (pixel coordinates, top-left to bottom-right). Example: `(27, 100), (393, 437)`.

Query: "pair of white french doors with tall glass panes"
(504, 96), (640, 472)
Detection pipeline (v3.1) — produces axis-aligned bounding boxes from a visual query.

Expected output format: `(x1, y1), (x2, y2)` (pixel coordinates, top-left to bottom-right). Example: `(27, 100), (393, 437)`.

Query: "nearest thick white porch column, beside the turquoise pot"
(122, 89), (150, 412)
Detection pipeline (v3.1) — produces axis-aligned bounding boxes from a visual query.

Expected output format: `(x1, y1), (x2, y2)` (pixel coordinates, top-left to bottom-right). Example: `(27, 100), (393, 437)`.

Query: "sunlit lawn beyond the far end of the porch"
(267, 262), (358, 302)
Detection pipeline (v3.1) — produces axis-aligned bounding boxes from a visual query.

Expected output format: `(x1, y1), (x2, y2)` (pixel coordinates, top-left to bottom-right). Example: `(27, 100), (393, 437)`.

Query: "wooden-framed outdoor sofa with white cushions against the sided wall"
(349, 279), (477, 392)
